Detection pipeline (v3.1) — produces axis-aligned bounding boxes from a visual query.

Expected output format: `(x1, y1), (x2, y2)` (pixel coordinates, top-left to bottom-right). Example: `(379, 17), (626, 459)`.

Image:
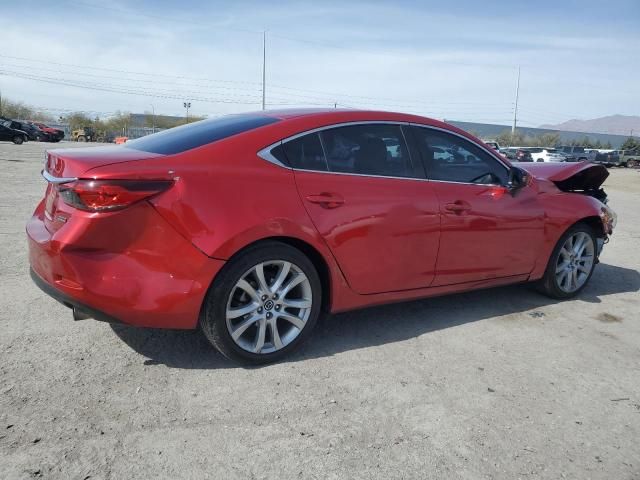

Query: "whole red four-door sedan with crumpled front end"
(27, 110), (615, 363)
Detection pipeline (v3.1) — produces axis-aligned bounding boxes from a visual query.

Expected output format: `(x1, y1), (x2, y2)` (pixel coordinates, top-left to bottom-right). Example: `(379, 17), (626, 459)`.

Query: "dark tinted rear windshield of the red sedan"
(125, 114), (279, 155)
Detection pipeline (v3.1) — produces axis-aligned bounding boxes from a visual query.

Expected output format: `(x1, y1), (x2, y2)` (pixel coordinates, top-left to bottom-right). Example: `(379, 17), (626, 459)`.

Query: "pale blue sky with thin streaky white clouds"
(0, 0), (640, 126)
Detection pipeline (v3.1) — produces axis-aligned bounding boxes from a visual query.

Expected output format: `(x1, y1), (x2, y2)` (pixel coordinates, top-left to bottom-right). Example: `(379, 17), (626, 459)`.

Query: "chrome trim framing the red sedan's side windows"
(257, 120), (509, 187)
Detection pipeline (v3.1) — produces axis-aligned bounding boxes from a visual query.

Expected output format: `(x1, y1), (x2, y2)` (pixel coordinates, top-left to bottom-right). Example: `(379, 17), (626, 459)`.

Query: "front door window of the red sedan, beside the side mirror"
(413, 127), (508, 185)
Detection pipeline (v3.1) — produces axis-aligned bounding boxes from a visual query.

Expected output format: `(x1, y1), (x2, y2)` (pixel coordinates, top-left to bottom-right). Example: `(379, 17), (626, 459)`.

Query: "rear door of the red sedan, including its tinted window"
(283, 123), (440, 294)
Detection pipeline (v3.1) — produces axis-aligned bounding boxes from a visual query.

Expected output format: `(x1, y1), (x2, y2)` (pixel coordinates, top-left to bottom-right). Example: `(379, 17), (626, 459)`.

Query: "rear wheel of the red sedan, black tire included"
(200, 241), (322, 364)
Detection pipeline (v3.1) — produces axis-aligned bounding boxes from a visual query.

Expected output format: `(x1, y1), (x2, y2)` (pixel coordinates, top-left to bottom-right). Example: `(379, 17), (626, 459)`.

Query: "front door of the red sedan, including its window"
(412, 127), (544, 286)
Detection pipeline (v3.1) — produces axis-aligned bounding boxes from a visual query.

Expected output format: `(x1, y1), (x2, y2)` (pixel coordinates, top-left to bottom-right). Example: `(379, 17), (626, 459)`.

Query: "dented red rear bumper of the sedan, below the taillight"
(27, 202), (224, 329)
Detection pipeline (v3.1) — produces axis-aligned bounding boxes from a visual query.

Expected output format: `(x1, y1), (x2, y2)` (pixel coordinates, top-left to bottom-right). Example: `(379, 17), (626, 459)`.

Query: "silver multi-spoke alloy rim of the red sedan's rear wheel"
(226, 260), (313, 354)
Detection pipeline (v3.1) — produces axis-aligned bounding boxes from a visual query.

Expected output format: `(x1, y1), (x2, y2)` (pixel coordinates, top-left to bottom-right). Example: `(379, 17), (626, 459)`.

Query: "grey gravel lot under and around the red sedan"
(0, 142), (640, 480)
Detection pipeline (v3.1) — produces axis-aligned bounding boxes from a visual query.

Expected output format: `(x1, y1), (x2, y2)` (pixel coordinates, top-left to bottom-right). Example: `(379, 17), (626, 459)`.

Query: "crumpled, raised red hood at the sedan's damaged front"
(518, 162), (609, 191)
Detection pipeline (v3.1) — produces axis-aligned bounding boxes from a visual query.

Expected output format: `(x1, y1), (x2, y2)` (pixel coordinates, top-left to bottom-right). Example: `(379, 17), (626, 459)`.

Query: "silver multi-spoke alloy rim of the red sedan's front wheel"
(555, 232), (595, 293)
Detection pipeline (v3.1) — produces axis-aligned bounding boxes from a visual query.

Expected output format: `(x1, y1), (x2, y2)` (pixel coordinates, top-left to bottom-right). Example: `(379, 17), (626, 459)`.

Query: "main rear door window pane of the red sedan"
(320, 124), (413, 177)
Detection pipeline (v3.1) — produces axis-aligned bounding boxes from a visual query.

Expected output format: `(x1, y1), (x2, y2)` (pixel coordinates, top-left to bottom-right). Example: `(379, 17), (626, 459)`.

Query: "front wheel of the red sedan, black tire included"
(537, 223), (598, 300)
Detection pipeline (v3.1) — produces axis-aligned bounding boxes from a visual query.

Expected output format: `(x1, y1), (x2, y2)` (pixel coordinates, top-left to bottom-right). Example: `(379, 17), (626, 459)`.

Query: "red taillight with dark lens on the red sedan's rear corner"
(58, 180), (173, 212)
